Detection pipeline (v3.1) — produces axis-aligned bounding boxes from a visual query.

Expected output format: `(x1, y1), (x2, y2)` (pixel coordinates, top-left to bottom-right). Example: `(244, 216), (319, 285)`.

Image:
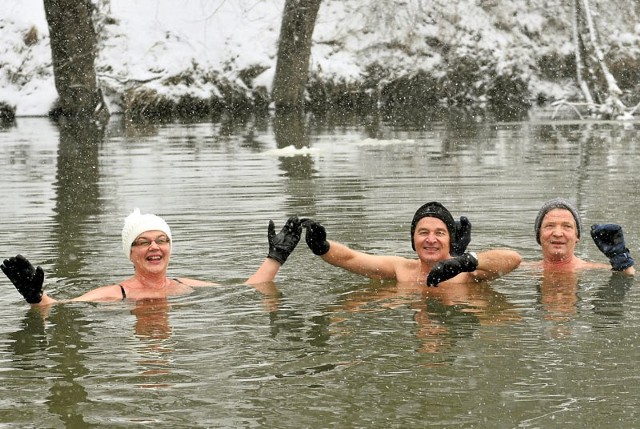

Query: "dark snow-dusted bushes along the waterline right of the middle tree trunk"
(307, 56), (531, 119)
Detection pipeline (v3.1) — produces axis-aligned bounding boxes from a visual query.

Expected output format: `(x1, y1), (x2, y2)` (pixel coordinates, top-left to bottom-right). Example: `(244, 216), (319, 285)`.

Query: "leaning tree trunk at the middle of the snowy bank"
(272, 0), (321, 110)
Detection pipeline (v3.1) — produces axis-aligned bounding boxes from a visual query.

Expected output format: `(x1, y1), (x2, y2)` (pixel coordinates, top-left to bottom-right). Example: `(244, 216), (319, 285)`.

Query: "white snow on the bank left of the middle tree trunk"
(0, 0), (284, 116)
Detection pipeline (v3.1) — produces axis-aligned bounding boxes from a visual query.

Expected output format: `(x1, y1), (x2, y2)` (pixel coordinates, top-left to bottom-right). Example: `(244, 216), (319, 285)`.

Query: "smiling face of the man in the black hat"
(413, 217), (451, 263)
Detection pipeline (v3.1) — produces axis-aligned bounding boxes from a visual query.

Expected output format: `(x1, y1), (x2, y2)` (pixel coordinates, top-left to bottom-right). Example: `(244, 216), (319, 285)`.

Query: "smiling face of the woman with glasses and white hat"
(130, 231), (171, 273)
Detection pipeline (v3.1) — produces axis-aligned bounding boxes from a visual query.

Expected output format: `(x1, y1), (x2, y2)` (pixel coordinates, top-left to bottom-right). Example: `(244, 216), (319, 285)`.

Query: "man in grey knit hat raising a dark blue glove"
(534, 198), (635, 274)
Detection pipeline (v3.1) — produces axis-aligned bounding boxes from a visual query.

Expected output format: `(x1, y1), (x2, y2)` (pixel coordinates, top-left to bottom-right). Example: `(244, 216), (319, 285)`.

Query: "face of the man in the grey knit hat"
(540, 208), (579, 261)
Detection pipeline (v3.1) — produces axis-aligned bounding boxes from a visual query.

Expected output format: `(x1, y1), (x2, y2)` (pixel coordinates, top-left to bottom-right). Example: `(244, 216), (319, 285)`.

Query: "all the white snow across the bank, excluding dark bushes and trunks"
(0, 0), (640, 116)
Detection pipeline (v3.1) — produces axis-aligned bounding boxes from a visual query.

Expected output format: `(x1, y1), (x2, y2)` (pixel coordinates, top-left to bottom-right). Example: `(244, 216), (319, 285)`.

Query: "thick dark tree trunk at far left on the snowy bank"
(44, 0), (109, 122)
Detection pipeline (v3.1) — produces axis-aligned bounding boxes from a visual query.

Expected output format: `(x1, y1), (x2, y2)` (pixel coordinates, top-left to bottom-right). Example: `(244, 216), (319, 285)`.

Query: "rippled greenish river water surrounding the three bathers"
(0, 112), (640, 428)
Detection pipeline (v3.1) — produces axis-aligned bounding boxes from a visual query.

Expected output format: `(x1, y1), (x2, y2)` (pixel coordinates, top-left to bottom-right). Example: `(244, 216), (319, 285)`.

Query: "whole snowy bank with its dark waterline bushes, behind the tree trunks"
(0, 0), (640, 116)
